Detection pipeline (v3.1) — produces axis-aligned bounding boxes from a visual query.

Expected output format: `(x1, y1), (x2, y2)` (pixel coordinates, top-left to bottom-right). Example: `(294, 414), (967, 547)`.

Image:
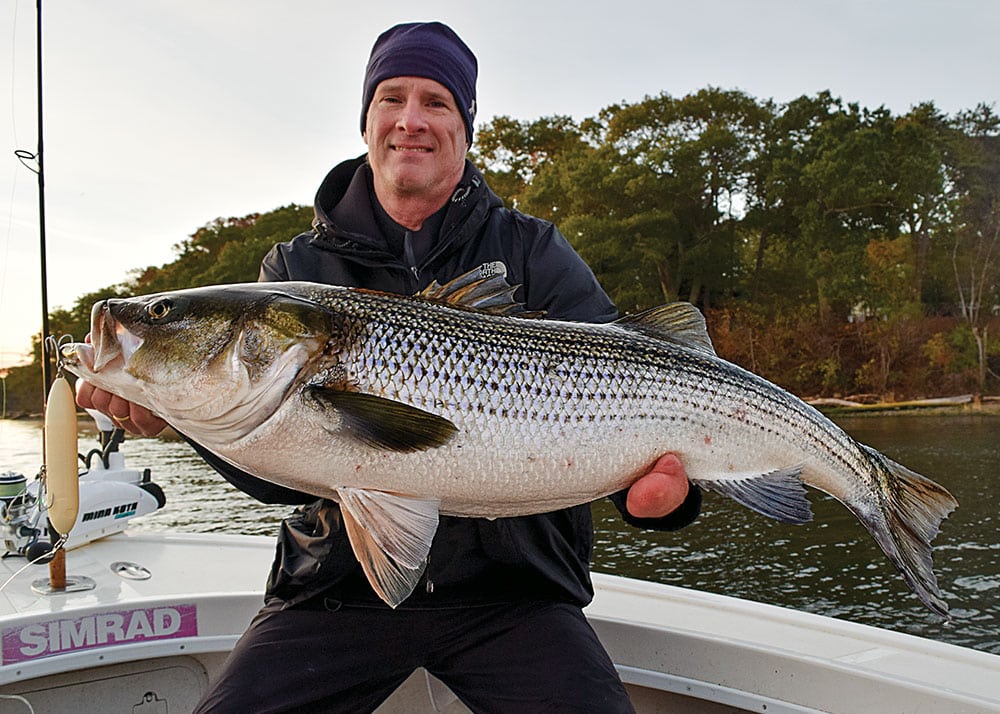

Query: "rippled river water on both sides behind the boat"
(0, 415), (1000, 654)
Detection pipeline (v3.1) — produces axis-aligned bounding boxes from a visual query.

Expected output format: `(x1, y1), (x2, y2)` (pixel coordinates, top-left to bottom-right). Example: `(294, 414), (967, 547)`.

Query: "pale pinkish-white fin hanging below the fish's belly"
(337, 488), (440, 607)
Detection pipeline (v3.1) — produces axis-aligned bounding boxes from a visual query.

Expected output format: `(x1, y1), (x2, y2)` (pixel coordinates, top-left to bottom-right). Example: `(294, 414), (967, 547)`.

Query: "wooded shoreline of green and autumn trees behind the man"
(7, 88), (1000, 411)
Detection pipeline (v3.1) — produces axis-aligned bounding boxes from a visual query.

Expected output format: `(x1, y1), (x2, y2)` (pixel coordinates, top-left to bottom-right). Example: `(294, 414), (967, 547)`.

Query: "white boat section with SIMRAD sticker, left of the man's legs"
(0, 533), (274, 714)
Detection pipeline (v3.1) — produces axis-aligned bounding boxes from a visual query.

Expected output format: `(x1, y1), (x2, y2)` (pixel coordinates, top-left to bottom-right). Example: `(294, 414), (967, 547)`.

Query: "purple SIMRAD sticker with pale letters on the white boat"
(2, 605), (198, 664)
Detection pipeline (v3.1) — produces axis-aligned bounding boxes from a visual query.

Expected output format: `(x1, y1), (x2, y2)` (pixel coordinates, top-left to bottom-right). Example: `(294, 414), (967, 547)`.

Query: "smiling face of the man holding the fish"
(364, 77), (469, 205)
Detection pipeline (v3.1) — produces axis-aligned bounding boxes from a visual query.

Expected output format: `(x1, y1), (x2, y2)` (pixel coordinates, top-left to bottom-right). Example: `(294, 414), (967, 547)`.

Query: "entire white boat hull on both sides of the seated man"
(0, 533), (1000, 714)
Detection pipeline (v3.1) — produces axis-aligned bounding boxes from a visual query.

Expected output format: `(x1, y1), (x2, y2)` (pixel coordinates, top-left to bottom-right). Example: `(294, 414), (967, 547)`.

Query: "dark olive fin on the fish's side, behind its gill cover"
(309, 386), (458, 452)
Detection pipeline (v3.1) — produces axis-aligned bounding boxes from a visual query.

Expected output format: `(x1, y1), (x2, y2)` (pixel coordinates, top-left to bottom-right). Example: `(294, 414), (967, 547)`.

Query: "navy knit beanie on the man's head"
(361, 22), (478, 146)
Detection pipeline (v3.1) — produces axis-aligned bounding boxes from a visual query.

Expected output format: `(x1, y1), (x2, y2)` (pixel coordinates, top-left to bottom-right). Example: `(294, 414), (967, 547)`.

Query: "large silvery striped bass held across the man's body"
(63, 266), (957, 616)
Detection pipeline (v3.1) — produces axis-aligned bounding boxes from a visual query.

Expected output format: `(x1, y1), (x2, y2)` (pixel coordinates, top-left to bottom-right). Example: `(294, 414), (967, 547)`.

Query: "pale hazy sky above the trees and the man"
(0, 0), (1000, 370)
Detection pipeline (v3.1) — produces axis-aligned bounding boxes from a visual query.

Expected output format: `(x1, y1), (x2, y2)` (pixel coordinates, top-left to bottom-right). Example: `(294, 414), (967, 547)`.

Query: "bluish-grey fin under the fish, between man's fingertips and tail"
(691, 465), (812, 524)
